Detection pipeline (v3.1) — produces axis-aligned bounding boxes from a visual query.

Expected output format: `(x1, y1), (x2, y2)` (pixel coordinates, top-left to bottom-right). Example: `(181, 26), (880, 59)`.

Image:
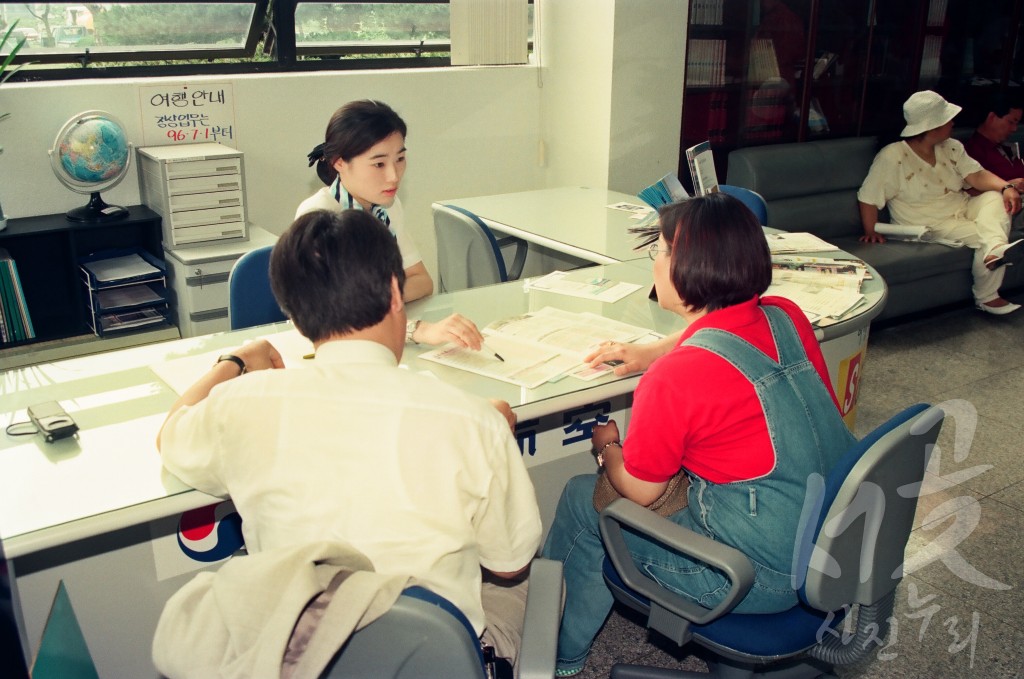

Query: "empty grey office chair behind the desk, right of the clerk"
(431, 203), (527, 292)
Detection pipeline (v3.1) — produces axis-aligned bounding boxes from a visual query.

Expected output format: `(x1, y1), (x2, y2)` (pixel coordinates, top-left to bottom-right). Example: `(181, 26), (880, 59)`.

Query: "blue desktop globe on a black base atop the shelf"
(49, 111), (131, 221)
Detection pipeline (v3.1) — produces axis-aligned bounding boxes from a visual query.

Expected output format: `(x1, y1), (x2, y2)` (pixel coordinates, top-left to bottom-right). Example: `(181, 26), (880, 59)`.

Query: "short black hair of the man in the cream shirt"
(270, 210), (406, 342)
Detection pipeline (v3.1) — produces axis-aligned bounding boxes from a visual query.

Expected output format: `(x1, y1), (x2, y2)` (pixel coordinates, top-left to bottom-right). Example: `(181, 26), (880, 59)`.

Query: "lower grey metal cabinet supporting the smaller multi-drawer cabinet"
(164, 226), (278, 337)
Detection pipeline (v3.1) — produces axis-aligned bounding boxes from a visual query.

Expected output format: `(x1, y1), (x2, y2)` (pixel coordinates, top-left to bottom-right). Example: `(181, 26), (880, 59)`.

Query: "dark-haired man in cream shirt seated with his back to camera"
(159, 210), (541, 675)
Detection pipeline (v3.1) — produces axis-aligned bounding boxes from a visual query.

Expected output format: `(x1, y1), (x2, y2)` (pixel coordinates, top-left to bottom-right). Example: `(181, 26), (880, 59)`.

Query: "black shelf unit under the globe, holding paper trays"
(0, 205), (164, 350)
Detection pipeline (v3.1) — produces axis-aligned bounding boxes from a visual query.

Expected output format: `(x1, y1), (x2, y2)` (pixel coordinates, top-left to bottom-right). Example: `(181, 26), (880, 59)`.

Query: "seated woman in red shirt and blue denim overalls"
(544, 194), (854, 676)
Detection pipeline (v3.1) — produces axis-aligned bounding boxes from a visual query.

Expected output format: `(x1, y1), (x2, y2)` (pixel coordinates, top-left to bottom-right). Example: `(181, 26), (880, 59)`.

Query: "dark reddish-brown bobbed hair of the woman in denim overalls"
(659, 188), (771, 311)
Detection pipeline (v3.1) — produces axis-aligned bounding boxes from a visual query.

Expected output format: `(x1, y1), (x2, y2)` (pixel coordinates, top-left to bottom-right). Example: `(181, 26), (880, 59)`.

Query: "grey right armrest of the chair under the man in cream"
(519, 558), (563, 679)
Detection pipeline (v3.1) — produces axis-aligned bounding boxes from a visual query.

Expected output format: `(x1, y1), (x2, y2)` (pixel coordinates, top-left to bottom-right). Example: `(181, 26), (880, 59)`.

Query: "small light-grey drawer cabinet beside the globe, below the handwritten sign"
(138, 143), (248, 248)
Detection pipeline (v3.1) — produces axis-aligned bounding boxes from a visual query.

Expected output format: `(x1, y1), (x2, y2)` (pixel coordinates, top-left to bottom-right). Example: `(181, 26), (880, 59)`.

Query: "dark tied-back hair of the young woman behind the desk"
(316, 99), (408, 185)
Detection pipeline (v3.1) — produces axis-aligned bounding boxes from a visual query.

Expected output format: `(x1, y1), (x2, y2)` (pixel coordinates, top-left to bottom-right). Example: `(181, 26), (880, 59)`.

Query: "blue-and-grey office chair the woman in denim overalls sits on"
(600, 405), (943, 679)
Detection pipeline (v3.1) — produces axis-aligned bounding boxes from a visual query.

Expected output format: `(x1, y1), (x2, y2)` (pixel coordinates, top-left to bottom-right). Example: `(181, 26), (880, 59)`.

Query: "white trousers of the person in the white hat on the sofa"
(933, 190), (1010, 304)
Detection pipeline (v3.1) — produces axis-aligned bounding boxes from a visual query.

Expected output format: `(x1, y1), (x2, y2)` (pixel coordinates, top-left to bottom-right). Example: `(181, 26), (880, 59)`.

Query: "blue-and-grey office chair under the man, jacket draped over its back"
(321, 559), (562, 679)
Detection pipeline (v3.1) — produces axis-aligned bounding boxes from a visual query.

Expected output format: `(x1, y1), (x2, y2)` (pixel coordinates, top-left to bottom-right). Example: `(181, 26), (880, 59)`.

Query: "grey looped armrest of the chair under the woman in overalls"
(599, 498), (754, 625)
